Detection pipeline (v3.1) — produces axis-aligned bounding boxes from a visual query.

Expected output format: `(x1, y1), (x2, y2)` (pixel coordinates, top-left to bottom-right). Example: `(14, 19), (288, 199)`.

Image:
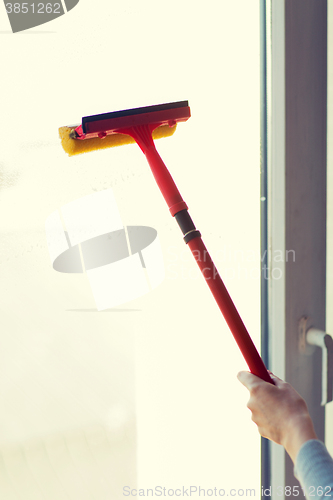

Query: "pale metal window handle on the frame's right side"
(306, 328), (333, 406)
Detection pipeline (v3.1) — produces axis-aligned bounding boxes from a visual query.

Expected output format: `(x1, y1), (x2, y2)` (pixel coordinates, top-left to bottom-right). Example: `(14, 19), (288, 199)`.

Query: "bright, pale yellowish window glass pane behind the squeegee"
(0, 0), (260, 500)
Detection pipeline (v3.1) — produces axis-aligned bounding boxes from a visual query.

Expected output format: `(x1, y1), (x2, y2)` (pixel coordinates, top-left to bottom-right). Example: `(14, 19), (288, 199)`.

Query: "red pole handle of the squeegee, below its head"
(127, 127), (274, 384)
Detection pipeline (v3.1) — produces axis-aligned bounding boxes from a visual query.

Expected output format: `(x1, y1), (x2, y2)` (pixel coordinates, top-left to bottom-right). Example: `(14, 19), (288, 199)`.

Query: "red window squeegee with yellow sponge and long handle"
(59, 101), (273, 383)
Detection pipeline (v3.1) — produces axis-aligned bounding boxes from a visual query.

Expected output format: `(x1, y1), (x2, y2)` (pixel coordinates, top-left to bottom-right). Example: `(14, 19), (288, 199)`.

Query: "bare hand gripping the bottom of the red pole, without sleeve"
(237, 371), (318, 462)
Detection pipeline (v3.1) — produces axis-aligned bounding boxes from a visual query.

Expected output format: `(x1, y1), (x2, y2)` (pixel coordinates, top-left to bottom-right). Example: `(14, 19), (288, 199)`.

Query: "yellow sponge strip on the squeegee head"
(59, 125), (177, 156)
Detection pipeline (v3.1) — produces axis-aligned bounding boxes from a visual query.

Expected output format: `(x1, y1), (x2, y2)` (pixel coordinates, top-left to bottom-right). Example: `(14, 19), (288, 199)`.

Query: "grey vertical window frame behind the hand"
(262, 0), (327, 499)
